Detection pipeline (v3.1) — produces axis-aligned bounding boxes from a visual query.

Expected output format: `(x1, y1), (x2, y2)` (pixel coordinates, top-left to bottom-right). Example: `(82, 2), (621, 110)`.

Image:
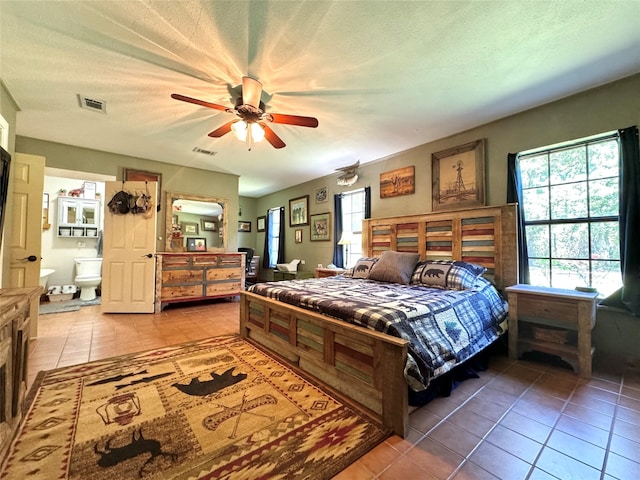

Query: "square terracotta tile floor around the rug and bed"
(29, 301), (640, 480)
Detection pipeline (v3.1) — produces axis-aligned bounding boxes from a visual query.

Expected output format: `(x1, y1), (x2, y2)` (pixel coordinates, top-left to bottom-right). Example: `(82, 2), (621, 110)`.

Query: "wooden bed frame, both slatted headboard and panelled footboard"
(240, 204), (518, 437)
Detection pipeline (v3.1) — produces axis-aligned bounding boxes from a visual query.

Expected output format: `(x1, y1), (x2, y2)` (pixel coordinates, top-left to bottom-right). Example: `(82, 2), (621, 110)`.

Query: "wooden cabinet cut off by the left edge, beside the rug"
(0, 287), (42, 459)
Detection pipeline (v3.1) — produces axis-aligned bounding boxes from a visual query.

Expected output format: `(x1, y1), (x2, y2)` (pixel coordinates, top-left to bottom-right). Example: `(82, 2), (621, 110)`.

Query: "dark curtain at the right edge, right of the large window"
(601, 126), (640, 317)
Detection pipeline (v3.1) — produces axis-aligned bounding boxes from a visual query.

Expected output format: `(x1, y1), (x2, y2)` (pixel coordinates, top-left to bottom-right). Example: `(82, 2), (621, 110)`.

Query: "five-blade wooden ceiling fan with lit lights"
(171, 77), (318, 150)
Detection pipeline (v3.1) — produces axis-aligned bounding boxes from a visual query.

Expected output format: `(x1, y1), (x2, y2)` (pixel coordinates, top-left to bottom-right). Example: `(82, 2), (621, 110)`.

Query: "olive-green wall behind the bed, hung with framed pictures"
(256, 75), (640, 278)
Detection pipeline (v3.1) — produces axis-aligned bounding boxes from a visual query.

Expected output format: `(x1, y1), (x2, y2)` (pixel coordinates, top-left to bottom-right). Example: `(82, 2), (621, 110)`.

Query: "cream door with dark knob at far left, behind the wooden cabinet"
(5, 153), (45, 338)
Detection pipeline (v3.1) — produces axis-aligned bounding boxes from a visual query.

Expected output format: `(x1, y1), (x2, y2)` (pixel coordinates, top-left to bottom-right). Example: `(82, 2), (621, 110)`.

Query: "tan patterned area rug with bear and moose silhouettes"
(0, 336), (388, 480)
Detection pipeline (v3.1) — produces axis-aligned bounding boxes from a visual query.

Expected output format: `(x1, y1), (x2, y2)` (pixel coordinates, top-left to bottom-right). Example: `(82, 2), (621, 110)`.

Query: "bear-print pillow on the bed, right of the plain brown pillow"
(411, 260), (487, 290)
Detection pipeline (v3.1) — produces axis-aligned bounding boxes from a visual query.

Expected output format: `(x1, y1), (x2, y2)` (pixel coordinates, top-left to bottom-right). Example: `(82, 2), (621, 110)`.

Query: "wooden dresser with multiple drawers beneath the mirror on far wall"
(155, 252), (245, 312)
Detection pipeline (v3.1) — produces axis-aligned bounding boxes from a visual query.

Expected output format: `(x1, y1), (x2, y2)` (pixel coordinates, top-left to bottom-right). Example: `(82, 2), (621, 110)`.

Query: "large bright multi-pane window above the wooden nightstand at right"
(518, 133), (622, 296)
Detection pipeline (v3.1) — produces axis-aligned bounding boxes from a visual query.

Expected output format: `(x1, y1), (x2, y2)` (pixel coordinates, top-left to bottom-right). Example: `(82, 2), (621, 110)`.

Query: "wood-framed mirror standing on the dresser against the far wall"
(165, 192), (229, 252)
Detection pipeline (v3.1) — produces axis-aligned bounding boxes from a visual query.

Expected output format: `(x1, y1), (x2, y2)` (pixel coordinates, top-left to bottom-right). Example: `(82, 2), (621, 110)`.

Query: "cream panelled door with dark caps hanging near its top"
(102, 182), (159, 313)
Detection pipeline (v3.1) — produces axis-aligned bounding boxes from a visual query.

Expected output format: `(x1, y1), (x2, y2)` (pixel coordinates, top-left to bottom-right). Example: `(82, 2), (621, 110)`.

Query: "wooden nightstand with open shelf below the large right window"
(505, 285), (598, 378)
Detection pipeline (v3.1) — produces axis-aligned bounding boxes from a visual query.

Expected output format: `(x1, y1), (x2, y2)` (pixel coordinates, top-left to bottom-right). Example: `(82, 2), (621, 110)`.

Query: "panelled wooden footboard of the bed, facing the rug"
(240, 292), (408, 436)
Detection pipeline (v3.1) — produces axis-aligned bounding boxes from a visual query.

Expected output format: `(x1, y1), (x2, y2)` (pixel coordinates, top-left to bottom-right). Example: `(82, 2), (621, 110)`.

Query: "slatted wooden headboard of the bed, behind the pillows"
(362, 204), (518, 290)
